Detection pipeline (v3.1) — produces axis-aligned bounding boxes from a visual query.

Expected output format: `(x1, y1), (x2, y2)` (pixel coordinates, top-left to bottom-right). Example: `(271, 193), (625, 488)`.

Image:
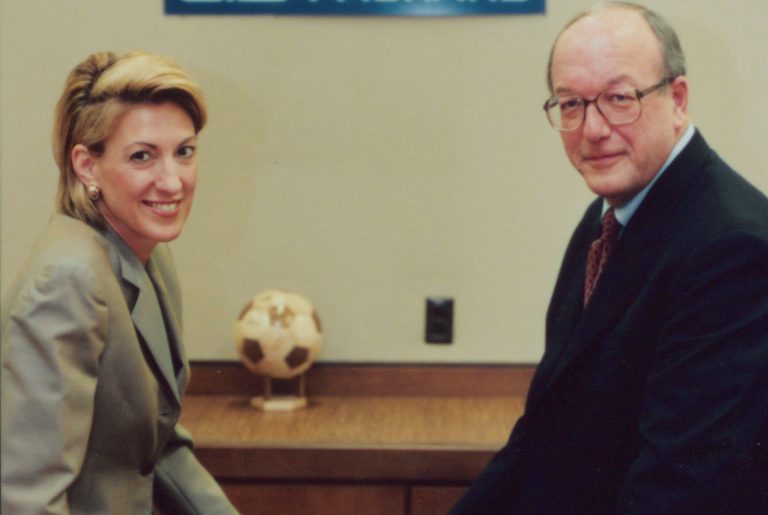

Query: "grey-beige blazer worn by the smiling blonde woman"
(0, 214), (236, 515)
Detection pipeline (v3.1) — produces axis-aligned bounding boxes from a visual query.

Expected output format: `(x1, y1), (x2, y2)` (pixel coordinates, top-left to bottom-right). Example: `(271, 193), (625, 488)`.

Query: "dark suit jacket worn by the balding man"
(452, 133), (768, 515)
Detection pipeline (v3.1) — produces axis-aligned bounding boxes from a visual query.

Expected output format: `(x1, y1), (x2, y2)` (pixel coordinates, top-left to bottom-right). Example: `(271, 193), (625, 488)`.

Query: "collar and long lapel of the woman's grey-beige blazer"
(103, 228), (183, 404)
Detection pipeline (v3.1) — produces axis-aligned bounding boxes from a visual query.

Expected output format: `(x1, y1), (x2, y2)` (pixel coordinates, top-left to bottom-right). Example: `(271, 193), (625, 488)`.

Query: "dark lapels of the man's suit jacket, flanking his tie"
(528, 132), (709, 406)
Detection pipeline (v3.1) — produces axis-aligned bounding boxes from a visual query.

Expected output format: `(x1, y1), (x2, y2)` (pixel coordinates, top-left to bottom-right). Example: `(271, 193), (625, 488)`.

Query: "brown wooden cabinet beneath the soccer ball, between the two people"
(181, 364), (532, 515)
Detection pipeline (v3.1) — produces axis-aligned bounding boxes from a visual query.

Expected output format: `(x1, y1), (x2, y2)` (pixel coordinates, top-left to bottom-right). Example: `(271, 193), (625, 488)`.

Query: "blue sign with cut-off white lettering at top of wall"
(165, 0), (546, 16)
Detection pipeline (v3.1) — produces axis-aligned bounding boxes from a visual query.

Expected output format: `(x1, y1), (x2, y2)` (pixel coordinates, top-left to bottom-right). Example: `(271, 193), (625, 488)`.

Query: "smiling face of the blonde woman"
(85, 102), (197, 262)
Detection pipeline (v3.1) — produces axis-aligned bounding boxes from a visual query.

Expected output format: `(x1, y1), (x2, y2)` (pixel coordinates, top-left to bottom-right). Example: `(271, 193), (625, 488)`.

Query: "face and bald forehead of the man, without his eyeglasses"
(551, 8), (688, 206)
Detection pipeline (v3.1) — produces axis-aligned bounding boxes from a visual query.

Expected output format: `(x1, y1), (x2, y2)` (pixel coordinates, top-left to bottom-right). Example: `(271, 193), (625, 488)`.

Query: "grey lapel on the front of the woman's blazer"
(104, 230), (181, 403)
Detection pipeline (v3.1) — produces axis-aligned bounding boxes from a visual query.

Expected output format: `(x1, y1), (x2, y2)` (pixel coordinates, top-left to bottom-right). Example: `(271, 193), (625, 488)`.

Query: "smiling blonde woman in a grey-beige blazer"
(0, 52), (236, 515)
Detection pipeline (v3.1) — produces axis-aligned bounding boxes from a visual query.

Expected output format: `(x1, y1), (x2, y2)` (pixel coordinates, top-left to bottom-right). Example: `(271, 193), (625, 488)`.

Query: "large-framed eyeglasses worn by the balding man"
(544, 77), (675, 132)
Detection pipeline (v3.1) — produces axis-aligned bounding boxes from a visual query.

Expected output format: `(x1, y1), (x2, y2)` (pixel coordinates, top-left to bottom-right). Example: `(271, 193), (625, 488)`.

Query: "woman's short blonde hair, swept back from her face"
(53, 51), (207, 226)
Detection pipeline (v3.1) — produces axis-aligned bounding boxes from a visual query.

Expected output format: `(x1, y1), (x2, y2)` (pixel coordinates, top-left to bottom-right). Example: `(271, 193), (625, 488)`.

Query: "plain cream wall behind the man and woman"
(0, 0), (768, 363)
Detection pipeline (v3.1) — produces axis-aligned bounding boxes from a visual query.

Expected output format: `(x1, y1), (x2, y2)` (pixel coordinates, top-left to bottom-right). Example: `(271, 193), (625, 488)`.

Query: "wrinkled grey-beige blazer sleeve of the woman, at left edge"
(0, 266), (108, 514)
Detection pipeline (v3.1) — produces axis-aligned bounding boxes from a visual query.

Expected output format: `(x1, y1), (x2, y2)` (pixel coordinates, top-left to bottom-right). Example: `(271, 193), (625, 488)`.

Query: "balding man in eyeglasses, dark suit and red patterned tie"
(452, 3), (768, 515)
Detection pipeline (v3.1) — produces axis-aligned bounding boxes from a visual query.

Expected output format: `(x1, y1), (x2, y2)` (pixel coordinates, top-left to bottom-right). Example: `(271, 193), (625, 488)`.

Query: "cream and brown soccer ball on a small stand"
(235, 290), (323, 379)
